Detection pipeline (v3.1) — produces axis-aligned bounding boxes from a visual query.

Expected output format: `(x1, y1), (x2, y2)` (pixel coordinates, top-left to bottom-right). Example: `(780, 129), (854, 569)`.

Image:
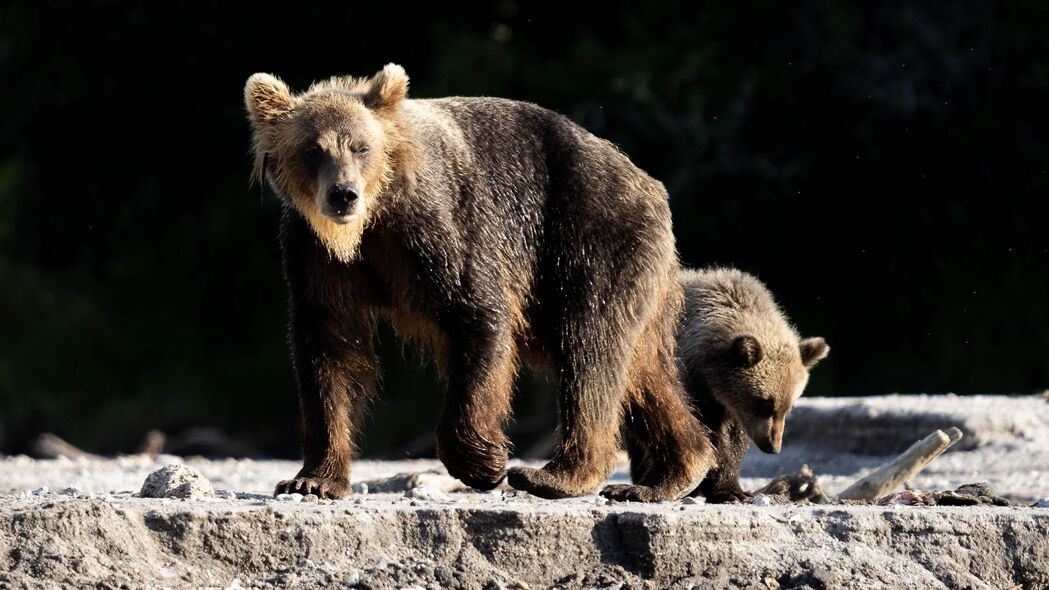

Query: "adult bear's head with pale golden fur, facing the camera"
(244, 64), (410, 261)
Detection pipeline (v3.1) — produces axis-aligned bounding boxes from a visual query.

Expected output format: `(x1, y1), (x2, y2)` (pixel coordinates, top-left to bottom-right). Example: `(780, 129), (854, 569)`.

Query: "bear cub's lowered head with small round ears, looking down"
(707, 333), (830, 454)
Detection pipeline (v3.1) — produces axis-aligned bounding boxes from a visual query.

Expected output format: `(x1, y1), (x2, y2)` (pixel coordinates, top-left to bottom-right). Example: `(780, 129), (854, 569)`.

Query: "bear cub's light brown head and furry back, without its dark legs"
(678, 269), (830, 454)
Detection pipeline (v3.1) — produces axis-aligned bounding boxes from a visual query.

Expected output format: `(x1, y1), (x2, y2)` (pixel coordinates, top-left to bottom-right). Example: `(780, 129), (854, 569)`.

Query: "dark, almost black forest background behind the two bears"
(0, 0), (1049, 456)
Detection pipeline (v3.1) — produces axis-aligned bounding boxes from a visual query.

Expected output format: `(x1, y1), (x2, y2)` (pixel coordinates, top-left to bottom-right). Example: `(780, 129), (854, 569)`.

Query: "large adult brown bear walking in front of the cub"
(244, 64), (714, 501)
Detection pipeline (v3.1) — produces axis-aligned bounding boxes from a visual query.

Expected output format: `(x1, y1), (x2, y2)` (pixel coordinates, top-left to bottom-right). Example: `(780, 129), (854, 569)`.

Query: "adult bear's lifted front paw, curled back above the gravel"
(437, 422), (509, 491)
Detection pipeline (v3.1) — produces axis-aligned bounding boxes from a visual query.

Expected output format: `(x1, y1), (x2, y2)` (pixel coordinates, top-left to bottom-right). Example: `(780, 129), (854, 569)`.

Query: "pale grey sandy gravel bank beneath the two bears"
(0, 396), (1049, 588)
